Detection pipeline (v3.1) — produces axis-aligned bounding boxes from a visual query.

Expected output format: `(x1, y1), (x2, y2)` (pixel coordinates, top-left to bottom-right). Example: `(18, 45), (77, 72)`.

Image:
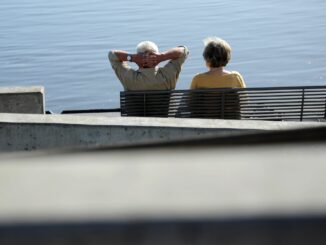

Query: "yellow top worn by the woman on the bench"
(190, 71), (246, 89)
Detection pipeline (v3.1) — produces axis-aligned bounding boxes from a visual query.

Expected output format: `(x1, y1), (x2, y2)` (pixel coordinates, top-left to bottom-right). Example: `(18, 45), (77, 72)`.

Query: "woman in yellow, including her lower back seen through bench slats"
(188, 37), (246, 119)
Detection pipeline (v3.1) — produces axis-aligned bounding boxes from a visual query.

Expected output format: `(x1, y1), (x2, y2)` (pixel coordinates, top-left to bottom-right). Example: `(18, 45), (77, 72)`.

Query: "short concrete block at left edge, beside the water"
(0, 87), (45, 114)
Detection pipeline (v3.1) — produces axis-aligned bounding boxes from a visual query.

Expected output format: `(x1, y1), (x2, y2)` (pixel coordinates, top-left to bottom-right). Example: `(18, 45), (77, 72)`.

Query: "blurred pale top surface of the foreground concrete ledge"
(0, 143), (326, 222)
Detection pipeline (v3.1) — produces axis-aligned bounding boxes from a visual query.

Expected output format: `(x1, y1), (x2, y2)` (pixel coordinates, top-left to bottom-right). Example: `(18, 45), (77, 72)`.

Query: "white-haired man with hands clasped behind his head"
(109, 41), (188, 91)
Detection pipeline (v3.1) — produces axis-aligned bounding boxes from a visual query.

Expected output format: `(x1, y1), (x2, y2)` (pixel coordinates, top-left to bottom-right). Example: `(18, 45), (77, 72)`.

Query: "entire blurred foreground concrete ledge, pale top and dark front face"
(0, 142), (326, 245)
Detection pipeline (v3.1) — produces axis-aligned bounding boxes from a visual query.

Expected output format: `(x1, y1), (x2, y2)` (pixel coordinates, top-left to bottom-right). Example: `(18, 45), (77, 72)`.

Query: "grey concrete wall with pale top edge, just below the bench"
(0, 113), (325, 152)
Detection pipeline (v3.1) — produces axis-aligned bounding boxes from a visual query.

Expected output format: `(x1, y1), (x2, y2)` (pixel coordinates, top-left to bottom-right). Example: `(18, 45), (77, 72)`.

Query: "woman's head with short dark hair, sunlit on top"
(203, 37), (231, 68)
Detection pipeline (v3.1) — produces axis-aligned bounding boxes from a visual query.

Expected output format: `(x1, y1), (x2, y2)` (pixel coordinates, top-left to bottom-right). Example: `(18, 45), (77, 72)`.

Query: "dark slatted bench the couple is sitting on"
(120, 86), (326, 121)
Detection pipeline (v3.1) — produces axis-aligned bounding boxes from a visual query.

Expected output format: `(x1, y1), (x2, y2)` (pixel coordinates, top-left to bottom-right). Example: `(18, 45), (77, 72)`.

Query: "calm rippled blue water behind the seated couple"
(0, 0), (326, 112)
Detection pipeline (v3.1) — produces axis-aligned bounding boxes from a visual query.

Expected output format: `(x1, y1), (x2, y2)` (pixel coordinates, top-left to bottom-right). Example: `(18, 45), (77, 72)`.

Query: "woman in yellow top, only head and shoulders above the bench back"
(190, 37), (246, 89)
